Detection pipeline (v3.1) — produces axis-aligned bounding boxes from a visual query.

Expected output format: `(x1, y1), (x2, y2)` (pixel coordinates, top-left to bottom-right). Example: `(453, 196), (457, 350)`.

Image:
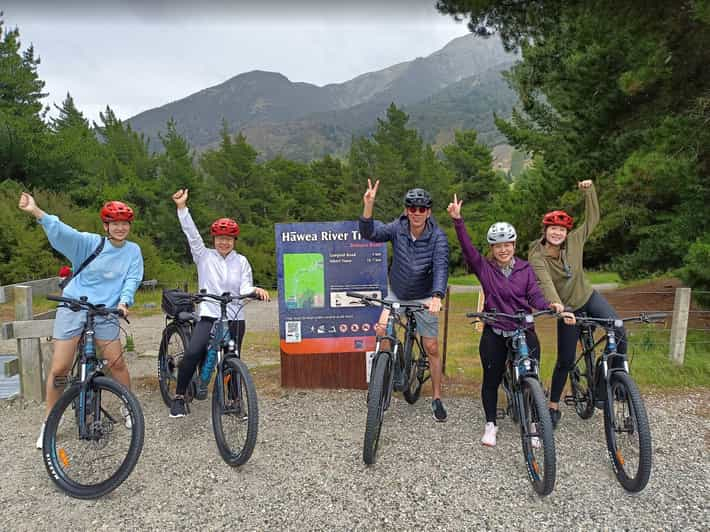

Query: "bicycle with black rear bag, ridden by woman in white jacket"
(159, 290), (259, 466)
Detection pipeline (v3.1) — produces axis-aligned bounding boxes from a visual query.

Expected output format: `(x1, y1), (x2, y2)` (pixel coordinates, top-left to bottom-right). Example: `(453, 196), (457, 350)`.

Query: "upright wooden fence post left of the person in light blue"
(13, 285), (44, 401)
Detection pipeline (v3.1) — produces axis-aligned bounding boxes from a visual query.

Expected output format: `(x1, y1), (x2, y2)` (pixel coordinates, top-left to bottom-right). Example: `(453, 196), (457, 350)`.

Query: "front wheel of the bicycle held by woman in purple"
(520, 377), (556, 495)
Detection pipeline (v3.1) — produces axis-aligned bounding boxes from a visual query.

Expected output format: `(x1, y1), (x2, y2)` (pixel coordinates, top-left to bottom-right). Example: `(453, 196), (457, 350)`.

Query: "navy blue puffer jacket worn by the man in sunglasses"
(359, 214), (449, 300)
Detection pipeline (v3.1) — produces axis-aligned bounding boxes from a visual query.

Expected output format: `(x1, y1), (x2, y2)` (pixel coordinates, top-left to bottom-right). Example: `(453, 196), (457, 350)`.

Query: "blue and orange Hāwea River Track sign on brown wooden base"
(275, 221), (387, 389)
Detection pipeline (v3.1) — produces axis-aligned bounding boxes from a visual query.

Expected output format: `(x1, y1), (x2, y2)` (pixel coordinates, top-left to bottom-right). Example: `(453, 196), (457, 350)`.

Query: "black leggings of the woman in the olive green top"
(550, 290), (626, 403)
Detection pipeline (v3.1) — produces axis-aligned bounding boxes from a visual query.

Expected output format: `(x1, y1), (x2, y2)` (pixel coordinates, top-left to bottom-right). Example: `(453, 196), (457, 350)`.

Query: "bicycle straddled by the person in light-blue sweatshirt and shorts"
(42, 296), (145, 499)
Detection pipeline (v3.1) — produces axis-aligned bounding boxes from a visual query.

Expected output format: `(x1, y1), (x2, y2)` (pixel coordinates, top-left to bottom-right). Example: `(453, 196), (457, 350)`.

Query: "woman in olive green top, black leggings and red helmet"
(528, 180), (626, 427)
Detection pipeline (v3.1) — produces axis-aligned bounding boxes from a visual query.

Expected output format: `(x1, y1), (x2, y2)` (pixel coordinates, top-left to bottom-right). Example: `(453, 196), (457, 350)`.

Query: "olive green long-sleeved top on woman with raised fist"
(528, 185), (599, 310)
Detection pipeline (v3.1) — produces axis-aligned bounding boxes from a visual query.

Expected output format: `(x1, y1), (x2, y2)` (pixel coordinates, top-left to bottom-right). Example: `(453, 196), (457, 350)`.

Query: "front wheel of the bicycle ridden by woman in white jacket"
(212, 357), (259, 466)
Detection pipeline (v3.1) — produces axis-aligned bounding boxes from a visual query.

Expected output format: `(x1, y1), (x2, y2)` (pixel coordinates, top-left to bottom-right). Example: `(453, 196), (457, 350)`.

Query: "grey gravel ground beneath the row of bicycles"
(0, 386), (710, 530)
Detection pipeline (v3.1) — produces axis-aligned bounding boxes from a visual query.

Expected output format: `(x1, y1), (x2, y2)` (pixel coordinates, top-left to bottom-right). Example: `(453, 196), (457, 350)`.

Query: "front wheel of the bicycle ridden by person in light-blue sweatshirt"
(42, 377), (144, 499)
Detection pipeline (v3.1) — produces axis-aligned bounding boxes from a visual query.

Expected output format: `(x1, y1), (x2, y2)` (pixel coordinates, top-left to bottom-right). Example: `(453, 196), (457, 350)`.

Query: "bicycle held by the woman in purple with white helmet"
(466, 310), (557, 495)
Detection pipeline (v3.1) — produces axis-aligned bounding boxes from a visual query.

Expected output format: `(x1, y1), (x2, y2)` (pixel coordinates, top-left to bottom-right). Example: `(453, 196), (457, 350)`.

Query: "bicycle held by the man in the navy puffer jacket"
(347, 292), (431, 465)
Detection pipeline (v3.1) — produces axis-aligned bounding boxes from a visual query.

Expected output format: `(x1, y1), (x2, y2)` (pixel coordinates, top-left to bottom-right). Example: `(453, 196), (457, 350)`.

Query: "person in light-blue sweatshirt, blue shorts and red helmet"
(19, 192), (143, 449)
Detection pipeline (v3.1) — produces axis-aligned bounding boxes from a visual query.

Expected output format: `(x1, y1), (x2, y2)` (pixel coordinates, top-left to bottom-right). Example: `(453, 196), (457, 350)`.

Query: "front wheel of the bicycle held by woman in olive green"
(604, 371), (652, 492)
